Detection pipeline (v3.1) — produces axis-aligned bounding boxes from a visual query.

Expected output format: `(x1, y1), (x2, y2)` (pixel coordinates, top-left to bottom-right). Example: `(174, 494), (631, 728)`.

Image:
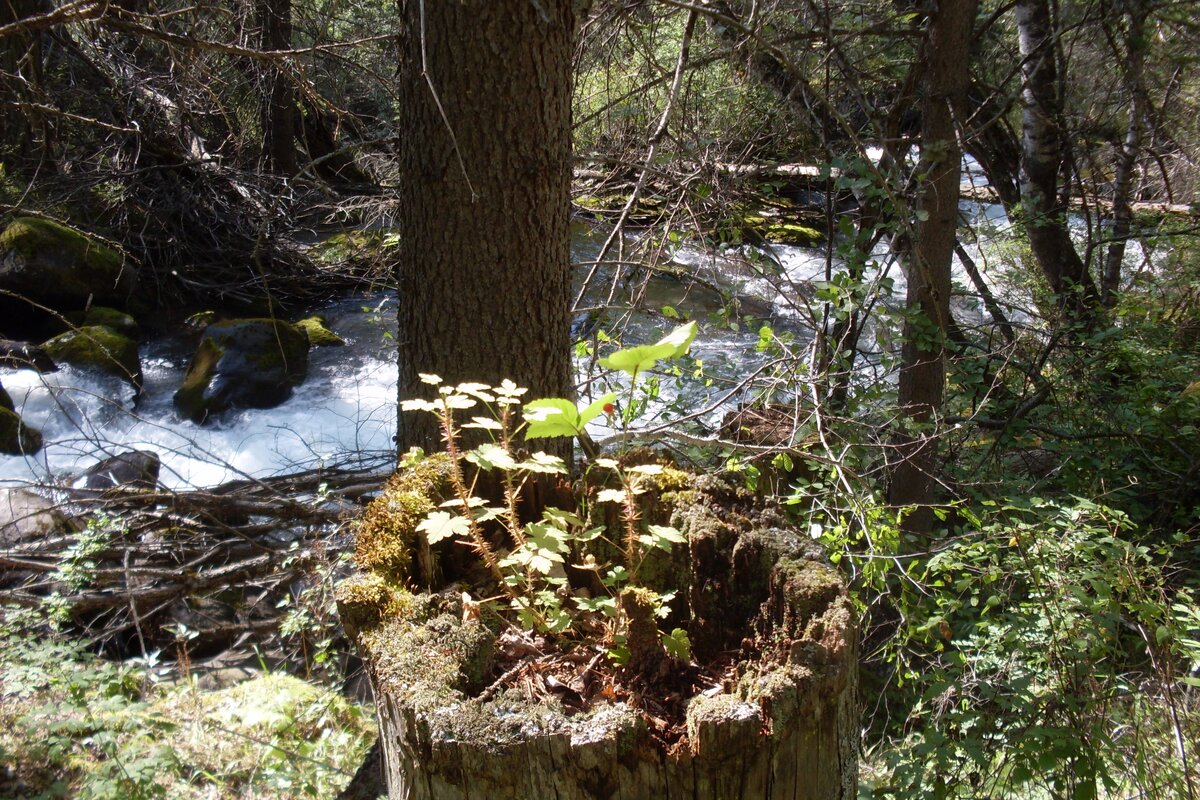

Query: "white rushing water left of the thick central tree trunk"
(0, 294), (396, 488)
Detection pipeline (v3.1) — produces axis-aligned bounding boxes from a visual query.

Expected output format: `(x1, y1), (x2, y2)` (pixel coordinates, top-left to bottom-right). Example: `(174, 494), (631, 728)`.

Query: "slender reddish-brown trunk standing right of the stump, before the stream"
(888, 0), (978, 535)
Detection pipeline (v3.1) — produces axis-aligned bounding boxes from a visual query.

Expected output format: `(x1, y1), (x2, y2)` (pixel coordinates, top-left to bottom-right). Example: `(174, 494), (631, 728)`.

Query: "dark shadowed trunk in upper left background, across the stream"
(254, 0), (296, 175)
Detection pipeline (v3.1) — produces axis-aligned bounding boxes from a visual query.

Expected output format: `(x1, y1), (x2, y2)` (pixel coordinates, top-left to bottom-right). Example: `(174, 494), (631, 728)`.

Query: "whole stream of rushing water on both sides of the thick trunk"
(0, 181), (1123, 488)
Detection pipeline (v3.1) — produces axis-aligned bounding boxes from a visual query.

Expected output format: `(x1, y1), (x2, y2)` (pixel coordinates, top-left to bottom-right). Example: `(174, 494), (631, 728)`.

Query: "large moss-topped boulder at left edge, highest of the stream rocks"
(0, 217), (138, 315)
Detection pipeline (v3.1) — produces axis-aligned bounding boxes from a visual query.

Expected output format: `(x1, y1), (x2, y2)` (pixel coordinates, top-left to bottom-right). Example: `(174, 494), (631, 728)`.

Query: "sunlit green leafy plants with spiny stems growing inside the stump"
(401, 323), (696, 661)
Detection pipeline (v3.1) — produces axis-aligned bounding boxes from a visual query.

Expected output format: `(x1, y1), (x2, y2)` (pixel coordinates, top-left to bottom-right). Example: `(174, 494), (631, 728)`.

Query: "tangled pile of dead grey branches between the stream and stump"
(0, 469), (384, 655)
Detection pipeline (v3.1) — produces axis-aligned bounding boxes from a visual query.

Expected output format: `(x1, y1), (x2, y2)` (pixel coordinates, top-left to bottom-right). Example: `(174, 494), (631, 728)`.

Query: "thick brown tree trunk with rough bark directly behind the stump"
(397, 0), (575, 452)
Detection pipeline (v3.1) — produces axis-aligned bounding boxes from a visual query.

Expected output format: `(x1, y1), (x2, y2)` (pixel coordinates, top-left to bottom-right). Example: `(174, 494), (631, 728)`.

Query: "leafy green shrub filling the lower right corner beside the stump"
(823, 498), (1200, 798)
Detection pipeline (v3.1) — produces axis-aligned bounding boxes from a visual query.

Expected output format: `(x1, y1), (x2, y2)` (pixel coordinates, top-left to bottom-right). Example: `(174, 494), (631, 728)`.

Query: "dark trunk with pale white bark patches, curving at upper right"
(1016, 0), (1096, 315)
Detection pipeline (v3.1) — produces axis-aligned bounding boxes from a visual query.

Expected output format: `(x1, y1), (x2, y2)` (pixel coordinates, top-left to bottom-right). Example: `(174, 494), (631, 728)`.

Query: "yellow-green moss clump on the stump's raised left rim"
(354, 453), (452, 581)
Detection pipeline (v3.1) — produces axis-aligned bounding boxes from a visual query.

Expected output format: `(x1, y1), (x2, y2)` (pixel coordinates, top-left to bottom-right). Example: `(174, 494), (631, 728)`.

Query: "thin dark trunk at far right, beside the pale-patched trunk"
(1100, 0), (1147, 307)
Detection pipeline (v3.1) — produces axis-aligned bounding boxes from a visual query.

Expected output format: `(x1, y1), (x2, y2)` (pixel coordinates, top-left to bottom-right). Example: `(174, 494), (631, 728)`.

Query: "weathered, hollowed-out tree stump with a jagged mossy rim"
(338, 467), (858, 800)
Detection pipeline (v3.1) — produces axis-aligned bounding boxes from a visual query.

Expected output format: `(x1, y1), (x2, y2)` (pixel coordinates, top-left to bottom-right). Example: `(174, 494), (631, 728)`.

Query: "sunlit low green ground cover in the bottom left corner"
(0, 608), (372, 800)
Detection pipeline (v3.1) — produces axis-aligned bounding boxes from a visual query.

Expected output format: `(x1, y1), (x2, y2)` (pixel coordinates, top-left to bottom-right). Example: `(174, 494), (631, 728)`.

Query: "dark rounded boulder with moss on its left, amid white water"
(175, 318), (308, 422)
